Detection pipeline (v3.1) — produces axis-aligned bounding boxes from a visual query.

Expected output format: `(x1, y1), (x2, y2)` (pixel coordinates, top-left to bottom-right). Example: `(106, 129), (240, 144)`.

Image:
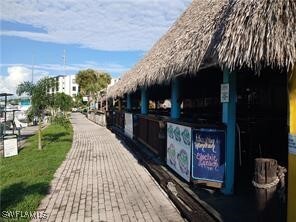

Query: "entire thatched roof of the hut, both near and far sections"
(108, 0), (296, 97)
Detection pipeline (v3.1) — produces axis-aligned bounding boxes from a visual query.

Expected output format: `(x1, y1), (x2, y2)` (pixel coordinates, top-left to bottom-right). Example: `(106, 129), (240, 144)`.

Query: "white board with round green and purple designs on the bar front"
(167, 123), (191, 182)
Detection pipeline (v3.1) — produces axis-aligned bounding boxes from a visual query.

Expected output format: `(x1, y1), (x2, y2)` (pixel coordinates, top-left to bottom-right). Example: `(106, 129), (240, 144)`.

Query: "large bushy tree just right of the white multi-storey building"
(76, 69), (111, 104)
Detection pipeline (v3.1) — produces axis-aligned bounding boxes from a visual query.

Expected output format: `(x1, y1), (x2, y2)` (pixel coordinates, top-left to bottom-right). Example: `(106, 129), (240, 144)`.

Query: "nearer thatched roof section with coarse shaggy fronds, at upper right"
(218, 0), (296, 71)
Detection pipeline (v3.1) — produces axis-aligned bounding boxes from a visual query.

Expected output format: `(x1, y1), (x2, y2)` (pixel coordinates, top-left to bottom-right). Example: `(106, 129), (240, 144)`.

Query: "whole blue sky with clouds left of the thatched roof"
(0, 0), (191, 93)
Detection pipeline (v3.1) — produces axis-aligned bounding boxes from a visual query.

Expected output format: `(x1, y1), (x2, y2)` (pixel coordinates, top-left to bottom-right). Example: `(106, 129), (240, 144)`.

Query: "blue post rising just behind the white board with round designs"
(171, 79), (181, 119)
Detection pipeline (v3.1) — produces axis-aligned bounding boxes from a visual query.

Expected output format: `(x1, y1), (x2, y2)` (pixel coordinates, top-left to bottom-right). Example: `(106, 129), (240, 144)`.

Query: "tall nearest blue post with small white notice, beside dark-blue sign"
(222, 70), (236, 195)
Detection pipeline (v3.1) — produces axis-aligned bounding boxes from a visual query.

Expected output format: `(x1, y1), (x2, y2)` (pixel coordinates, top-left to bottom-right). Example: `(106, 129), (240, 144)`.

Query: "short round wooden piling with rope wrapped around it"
(253, 158), (279, 222)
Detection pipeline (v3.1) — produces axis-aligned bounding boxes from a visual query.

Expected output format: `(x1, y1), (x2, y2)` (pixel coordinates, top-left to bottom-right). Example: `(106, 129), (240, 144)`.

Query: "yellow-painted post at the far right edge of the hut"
(287, 63), (296, 222)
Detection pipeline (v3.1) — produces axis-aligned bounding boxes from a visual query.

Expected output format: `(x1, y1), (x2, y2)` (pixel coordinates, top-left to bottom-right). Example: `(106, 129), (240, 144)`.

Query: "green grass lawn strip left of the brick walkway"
(0, 125), (73, 221)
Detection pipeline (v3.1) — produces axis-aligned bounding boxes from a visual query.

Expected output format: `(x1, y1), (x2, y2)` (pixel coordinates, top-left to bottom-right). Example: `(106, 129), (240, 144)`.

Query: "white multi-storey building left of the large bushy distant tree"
(49, 75), (79, 98)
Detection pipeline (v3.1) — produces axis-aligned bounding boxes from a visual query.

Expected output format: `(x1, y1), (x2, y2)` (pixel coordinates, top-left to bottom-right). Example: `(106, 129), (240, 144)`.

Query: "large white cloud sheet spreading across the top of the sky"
(0, 0), (191, 50)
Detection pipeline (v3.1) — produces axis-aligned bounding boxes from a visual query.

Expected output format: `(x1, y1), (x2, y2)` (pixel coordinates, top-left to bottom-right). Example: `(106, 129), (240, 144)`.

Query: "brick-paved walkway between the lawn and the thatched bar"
(34, 113), (183, 222)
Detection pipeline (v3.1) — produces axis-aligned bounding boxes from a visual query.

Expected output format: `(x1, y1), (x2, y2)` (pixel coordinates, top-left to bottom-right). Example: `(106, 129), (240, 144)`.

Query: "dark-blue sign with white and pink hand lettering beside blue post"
(192, 129), (225, 183)
